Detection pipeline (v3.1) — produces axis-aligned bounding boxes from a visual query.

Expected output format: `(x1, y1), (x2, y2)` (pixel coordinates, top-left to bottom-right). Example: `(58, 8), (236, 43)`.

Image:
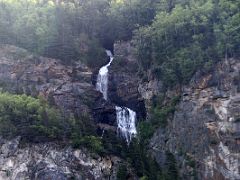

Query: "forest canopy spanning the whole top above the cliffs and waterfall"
(0, 0), (240, 85)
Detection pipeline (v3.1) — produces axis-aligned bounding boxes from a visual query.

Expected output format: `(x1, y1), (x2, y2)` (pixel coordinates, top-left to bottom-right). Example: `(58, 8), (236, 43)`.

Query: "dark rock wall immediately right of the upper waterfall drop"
(109, 42), (146, 120)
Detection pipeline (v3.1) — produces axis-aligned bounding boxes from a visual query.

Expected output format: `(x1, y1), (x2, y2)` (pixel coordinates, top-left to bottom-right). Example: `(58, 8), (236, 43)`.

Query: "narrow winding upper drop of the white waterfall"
(96, 50), (113, 100)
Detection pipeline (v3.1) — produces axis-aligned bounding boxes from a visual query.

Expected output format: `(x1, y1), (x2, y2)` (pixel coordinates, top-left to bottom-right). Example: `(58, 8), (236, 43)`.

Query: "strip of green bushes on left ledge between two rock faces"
(0, 93), (97, 146)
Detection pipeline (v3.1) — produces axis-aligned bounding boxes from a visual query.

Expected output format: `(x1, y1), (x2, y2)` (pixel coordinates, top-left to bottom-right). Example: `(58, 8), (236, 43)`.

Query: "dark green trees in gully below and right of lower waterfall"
(111, 96), (180, 180)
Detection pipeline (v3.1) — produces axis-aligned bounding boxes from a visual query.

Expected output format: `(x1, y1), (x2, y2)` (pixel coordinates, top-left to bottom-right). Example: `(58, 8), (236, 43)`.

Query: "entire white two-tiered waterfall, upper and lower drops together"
(96, 50), (137, 144)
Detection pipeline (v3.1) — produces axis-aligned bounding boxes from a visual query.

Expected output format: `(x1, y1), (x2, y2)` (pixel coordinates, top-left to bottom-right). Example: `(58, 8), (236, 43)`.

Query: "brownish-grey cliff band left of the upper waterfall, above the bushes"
(0, 46), (101, 119)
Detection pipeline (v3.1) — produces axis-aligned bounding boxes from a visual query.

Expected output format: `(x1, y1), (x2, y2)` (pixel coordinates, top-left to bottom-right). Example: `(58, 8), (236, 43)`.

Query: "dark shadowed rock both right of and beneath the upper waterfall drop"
(93, 42), (146, 131)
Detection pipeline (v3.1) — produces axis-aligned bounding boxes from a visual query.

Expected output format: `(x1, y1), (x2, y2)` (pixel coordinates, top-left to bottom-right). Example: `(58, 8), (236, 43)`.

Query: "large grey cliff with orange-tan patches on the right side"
(150, 59), (240, 180)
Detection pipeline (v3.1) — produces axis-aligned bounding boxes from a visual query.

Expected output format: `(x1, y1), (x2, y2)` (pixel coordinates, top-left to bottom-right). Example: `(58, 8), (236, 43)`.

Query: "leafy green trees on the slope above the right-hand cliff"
(134, 0), (240, 86)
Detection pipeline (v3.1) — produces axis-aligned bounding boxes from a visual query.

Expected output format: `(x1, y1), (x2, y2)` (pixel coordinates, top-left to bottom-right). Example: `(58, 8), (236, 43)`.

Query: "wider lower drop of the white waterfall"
(116, 106), (137, 144)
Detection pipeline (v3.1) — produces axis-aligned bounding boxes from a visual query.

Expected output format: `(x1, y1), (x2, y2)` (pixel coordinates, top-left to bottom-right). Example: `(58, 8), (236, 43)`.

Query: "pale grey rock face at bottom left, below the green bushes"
(0, 138), (121, 180)
